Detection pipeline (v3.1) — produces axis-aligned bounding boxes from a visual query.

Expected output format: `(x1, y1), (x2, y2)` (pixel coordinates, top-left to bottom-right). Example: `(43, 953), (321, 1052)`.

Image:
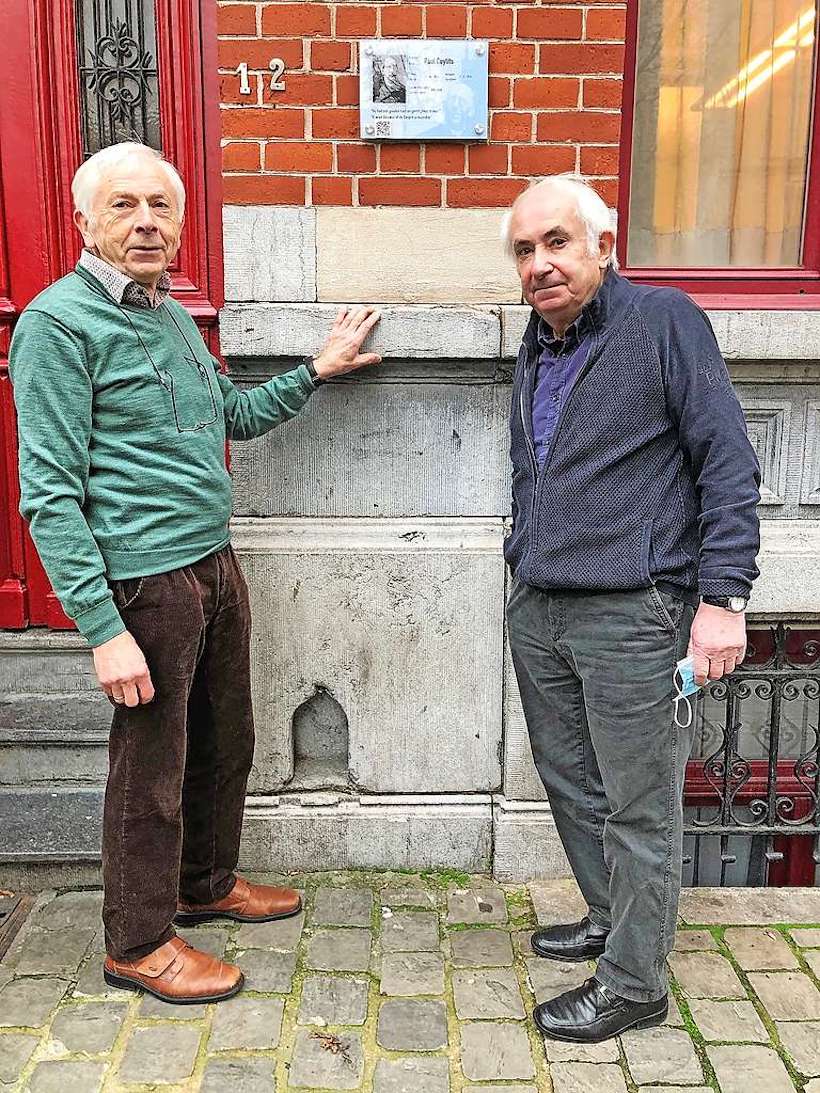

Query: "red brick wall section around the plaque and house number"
(219, 0), (625, 208)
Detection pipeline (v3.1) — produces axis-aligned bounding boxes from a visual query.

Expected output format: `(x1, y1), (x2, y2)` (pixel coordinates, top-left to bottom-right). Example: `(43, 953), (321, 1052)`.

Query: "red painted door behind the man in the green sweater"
(0, 0), (222, 628)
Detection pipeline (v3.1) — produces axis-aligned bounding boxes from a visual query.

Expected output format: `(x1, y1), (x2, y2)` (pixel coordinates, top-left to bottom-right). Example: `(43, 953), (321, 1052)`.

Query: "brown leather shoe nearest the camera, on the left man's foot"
(103, 938), (245, 1006)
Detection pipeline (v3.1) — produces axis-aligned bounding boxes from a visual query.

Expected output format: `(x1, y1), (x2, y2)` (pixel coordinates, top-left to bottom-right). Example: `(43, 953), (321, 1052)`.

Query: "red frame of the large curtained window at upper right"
(618, 0), (820, 310)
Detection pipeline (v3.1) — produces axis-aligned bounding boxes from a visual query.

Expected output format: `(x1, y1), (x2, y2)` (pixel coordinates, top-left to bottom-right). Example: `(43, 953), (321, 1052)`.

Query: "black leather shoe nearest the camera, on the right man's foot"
(532, 977), (669, 1044)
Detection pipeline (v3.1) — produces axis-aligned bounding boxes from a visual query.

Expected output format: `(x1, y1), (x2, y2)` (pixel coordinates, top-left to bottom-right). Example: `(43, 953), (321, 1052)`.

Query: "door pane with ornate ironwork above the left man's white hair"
(74, 0), (162, 156)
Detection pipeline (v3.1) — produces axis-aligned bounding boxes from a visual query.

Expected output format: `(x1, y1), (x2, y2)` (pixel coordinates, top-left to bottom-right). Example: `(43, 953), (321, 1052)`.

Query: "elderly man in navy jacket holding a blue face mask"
(505, 177), (760, 1043)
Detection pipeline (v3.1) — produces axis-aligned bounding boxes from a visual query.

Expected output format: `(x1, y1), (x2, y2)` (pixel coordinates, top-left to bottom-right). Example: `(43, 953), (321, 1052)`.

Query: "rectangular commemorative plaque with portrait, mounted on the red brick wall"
(359, 38), (490, 141)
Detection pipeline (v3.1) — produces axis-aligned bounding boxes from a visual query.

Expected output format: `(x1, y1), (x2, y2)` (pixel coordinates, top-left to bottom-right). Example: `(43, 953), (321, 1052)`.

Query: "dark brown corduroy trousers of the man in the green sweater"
(103, 547), (254, 960)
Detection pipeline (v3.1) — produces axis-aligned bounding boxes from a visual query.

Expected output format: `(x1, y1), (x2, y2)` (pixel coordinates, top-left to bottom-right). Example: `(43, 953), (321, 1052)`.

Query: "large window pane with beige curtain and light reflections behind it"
(628, 0), (817, 267)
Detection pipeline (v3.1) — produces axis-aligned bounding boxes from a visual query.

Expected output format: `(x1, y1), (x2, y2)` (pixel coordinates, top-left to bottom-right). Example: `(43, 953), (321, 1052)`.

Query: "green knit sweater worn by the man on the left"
(10, 267), (314, 645)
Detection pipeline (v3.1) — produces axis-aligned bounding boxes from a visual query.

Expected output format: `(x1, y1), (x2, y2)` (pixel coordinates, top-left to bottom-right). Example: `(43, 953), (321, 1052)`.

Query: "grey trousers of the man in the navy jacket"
(507, 580), (694, 1001)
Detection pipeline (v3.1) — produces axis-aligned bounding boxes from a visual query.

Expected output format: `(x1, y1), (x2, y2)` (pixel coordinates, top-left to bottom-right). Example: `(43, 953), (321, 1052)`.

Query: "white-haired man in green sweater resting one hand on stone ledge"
(11, 143), (379, 1003)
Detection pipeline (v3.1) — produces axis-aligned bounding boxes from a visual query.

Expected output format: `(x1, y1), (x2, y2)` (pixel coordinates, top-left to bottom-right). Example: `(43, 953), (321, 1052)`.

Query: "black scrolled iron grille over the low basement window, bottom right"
(684, 623), (820, 885)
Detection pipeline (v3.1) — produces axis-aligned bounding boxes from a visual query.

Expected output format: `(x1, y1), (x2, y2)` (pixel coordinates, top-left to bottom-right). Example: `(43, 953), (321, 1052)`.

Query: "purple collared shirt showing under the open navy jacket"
(532, 319), (590, 467)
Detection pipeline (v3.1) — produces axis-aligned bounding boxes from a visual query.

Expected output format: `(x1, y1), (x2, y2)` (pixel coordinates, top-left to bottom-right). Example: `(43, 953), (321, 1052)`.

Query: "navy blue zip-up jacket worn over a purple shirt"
(504, 270), (760, 599)
